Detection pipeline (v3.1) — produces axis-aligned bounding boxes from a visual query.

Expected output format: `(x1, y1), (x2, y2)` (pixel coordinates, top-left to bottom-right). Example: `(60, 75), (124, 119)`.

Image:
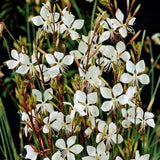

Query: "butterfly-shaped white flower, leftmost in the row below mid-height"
(32, 88), (53, 113)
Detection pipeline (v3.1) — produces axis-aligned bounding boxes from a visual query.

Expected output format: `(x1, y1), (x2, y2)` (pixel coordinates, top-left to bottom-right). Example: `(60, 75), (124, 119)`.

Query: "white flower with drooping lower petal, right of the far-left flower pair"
(46, 52), (73, 78)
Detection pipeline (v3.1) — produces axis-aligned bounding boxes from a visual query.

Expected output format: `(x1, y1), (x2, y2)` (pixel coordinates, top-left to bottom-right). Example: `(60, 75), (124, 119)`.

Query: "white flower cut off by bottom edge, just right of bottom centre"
(82, 142), (109, 160)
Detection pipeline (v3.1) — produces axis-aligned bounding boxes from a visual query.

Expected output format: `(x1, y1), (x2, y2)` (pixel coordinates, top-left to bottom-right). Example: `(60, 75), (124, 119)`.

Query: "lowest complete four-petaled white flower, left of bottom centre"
(55, 136), (83, 160)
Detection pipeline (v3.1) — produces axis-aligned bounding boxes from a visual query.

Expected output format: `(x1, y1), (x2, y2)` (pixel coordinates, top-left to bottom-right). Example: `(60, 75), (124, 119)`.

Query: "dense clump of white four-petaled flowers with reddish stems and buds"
(6, 2), (155, 160)
